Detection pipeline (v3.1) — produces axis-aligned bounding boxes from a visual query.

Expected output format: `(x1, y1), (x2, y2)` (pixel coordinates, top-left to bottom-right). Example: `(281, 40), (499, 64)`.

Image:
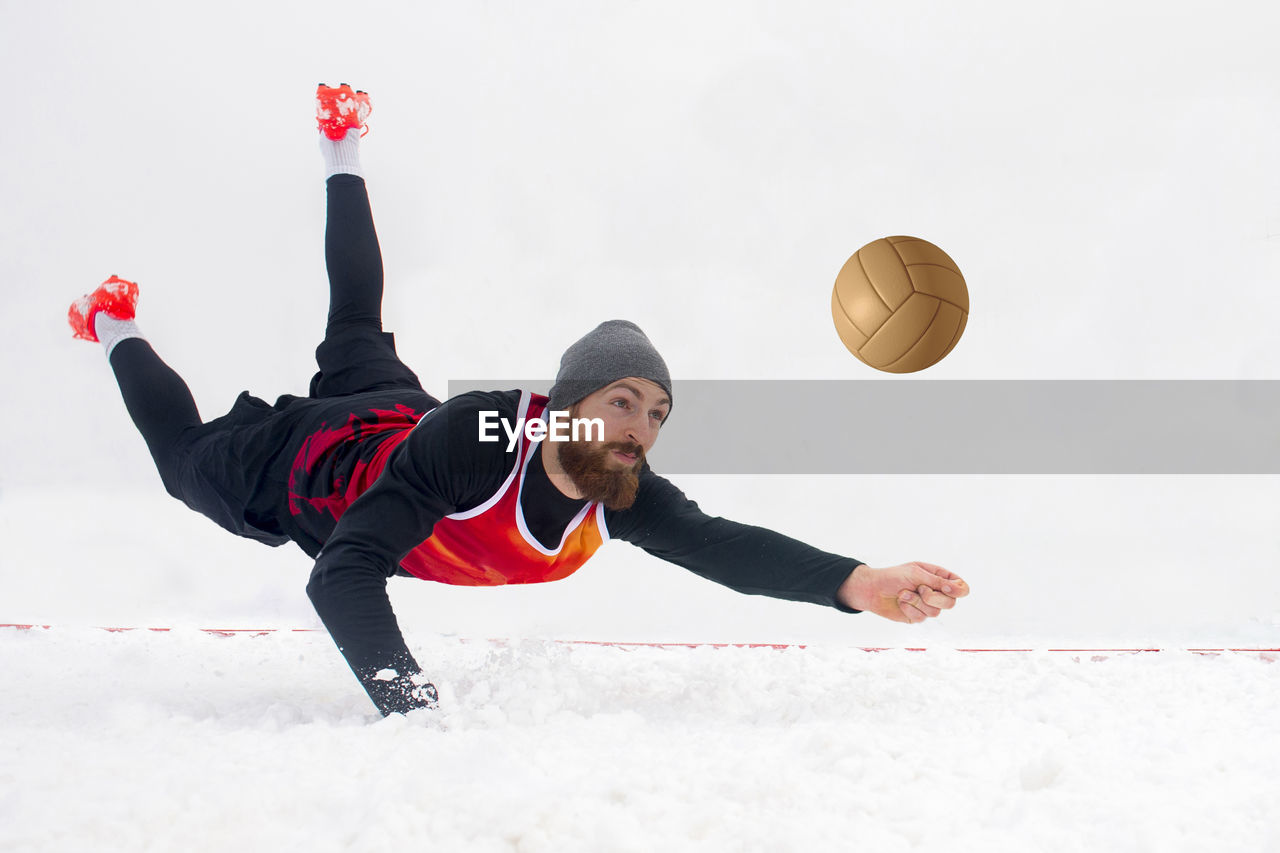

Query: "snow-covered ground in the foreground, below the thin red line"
(0, 629), (1280, 853)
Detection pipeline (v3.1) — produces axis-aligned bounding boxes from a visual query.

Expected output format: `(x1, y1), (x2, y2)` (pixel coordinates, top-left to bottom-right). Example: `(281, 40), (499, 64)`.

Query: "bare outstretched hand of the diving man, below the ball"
(836, 562), (969, 622)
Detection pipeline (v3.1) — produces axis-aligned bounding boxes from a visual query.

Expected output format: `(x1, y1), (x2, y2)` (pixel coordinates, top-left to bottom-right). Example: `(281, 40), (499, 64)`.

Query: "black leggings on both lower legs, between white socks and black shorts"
(111, 174), (383, 497)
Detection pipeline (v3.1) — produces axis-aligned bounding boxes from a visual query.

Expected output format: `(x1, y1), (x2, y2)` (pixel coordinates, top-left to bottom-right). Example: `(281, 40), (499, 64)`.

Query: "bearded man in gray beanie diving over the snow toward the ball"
(69, 85), (968, 715)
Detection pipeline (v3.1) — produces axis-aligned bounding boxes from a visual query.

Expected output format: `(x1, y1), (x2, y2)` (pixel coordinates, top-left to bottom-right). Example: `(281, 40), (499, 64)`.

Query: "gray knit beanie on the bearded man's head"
(549, 320), (671, 411)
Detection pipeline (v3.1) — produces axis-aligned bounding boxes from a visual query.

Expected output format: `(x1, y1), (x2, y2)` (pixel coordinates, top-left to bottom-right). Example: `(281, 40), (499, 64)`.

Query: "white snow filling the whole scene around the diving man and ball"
(0, 0), (1280, 853)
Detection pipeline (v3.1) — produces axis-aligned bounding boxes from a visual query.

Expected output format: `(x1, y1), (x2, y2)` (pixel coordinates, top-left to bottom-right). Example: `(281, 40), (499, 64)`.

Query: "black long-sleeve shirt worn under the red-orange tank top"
(278, 391), (861, 713)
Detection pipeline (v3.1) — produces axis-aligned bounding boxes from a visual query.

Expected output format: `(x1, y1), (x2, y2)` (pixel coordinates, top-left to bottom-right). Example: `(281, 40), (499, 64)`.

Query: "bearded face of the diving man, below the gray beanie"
(559, 378), (671, 510)
